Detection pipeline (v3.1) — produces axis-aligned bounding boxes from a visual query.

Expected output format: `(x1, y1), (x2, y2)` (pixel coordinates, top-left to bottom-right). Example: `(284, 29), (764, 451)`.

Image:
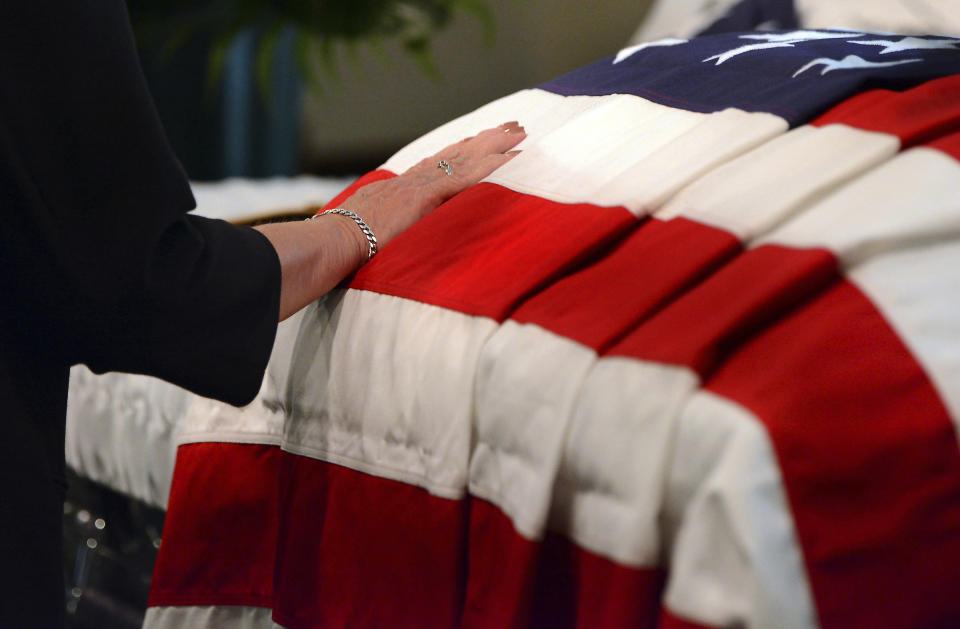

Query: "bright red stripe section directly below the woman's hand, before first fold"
(350, 183), (637, 320)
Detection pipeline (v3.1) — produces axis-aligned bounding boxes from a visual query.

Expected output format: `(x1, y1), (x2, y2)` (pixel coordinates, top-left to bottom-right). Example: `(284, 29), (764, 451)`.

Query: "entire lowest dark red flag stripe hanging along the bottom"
(150, 443), (664, 629)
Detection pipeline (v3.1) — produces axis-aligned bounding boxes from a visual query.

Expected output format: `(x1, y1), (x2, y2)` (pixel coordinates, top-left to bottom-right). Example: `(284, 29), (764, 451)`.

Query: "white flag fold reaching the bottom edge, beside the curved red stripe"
(664, 391), (817, 629)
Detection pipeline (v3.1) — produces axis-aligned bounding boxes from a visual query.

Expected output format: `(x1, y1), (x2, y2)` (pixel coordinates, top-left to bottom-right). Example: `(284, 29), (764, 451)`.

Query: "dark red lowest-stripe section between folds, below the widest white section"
(274, 454), (468, 629)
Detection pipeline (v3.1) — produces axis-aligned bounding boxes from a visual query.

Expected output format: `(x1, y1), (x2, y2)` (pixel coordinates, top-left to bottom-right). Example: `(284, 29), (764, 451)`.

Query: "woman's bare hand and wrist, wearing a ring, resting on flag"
(255, 122), (526, 321)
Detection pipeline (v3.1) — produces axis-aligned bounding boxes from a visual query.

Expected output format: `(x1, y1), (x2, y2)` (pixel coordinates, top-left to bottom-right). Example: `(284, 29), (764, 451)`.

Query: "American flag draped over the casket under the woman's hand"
(147, 30), (960, 629)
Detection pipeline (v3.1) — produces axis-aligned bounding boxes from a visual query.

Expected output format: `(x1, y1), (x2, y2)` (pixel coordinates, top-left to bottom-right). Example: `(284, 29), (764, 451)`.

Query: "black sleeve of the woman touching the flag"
(0, 0), (280, 404)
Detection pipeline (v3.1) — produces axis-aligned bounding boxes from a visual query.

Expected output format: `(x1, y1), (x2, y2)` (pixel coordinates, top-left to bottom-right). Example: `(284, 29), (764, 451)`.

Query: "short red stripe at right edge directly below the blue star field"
(812, 75), (960, 148)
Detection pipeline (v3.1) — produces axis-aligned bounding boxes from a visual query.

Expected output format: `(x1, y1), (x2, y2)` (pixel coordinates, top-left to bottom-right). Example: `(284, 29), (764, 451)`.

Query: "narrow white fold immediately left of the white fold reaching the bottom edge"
(550, 357), (698, 567)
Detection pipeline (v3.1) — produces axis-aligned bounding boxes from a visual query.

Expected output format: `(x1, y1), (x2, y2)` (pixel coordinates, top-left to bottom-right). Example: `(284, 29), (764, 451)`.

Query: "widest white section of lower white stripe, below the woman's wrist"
(274, 290), (497, 498)
